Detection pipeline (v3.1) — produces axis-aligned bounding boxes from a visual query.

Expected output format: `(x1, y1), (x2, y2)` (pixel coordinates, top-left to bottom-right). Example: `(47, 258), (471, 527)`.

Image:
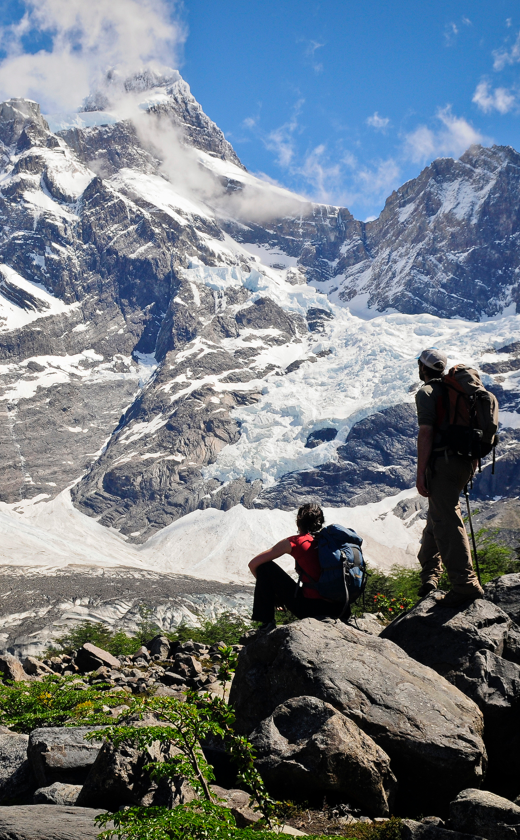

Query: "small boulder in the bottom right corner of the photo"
(449, 789), (520, 840)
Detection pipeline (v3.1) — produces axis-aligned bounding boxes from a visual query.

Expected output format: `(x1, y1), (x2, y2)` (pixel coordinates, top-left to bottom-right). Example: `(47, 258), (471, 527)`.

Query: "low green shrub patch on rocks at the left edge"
(0, 674), (121, 733)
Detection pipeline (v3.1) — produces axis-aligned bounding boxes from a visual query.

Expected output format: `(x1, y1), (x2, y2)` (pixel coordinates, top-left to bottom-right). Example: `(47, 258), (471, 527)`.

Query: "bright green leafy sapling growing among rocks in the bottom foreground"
(92, 693), (400, 840)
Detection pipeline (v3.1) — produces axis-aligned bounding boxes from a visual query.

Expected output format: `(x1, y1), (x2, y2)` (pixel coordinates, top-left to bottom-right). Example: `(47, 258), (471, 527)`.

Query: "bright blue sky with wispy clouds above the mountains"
(0, 0), (520, 219)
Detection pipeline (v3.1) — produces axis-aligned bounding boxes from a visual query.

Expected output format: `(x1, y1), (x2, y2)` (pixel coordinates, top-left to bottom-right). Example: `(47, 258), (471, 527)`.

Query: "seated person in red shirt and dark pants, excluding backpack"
(249, 504), (343, 630)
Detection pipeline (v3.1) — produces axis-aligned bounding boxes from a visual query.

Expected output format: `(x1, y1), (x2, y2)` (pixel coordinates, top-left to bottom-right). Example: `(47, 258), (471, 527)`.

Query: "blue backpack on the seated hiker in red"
(298, 525), (367, 618)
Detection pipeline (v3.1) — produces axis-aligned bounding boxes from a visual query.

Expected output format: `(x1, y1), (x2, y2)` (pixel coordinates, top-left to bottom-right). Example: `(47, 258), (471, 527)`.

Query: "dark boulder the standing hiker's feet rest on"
(381, 592), (520, 796)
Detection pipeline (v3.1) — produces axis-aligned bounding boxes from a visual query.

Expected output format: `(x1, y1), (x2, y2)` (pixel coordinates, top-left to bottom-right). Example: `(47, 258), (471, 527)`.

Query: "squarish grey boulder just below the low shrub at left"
(27, 726), (100, 787)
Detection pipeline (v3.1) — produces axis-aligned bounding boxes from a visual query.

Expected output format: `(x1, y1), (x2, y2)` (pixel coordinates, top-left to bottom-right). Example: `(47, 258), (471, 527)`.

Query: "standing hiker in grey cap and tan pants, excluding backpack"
(415, 348), (484, 606)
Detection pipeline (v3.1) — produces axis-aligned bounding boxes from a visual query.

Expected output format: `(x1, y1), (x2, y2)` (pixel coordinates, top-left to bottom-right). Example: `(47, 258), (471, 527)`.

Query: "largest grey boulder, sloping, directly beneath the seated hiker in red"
(230, 618), (486, 813)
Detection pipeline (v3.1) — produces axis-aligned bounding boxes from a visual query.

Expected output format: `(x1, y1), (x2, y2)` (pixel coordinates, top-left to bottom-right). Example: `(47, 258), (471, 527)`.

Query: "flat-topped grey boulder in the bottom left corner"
(0, 805), (110, 840)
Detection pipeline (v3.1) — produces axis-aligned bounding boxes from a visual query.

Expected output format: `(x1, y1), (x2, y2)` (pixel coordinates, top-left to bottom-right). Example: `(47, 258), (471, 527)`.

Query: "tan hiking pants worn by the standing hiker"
(418, 453), (481, 595)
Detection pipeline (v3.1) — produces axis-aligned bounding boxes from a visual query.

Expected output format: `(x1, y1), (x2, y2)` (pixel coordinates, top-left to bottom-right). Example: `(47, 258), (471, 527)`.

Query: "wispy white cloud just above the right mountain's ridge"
(404, 105), (485, 163)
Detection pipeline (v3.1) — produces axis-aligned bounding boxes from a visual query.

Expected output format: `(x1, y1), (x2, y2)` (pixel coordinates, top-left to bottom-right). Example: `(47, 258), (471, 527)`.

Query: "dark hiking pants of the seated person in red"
(252, 560), (342, 623)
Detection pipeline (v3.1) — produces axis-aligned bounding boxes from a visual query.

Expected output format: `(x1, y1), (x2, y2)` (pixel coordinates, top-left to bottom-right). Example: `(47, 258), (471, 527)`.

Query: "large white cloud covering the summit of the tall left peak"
(0, 0), (186, 113)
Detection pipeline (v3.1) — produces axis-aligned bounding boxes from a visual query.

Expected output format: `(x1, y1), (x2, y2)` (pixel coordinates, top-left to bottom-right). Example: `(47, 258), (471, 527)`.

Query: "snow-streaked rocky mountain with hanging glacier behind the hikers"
(0, 72), (520, 564)
